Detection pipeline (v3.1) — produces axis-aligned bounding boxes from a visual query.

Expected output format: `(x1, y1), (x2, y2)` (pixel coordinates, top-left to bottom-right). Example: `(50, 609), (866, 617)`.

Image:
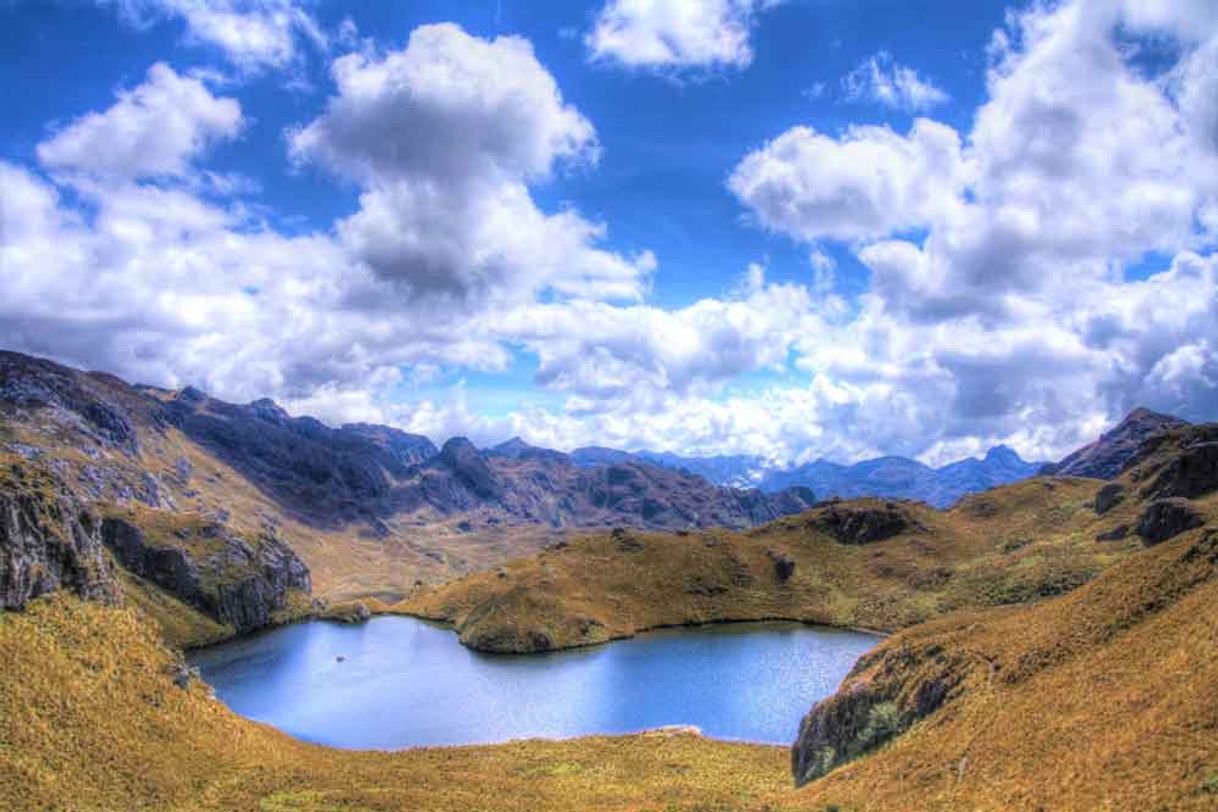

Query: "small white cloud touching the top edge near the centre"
(585, 0), (776, 68)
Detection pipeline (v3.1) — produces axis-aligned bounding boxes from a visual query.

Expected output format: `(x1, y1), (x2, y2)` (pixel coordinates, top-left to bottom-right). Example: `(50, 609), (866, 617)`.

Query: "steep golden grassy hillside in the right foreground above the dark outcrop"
(790, 518), (1218, 810)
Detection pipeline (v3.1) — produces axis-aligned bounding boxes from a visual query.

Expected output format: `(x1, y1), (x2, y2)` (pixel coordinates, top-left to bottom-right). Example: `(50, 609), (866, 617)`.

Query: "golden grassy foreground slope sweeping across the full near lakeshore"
(0, 503), (1218, 812)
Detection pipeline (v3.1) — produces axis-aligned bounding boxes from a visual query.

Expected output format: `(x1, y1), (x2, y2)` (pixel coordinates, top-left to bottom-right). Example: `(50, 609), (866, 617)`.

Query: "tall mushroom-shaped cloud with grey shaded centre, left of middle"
(291, 24), (655, 306)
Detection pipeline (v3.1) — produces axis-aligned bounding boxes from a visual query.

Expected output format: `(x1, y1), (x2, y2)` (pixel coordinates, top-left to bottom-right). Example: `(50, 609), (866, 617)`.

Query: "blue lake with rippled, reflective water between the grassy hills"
(190, 616), (878, 749)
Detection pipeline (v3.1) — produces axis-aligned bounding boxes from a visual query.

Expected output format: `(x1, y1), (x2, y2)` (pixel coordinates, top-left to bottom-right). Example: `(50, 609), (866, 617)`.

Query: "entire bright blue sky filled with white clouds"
(0, 0), (1218, 464)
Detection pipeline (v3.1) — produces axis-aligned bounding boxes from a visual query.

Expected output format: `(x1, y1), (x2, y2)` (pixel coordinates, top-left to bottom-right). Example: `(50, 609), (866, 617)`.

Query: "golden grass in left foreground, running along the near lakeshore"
(0, 597), (790, 811)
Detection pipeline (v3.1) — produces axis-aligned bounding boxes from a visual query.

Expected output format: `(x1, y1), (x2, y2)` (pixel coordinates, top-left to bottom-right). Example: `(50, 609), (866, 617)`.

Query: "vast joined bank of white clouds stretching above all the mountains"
(0, 0), (1218, 461)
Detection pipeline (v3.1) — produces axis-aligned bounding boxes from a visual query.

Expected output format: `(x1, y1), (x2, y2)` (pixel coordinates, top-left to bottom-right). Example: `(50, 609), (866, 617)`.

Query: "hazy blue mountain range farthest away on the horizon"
(571, 446), (1043, 508)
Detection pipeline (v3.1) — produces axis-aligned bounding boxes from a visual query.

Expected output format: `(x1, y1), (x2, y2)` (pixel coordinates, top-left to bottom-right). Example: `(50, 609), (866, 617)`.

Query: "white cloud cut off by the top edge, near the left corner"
(99, 0), (326, 71)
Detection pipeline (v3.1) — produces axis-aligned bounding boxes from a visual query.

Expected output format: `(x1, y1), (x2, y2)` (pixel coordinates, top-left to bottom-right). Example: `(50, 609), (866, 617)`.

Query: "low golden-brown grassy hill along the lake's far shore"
(409, 478), (1141, 651)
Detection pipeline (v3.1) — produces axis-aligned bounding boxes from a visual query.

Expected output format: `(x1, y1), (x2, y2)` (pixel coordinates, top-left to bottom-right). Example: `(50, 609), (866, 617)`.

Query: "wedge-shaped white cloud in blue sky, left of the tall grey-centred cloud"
(38, 62), (242, 181)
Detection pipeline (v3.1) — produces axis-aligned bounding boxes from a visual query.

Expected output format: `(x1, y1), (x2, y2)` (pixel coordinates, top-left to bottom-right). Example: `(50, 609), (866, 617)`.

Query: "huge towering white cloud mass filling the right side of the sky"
(711, 0), (1218, 459)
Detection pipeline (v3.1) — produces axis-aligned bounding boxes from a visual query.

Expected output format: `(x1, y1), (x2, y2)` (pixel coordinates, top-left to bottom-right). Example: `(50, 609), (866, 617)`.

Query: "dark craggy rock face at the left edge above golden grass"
(0, 464), (118, 609)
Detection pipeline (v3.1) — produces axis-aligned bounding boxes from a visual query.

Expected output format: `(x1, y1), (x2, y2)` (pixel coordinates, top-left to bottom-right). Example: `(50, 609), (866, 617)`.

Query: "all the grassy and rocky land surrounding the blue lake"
(0, 358), (1218, 810)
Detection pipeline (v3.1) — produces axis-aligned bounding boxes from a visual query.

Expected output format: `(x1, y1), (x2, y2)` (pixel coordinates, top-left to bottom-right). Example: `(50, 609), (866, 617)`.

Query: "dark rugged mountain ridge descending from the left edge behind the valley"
(0, 352), (814, 537)
